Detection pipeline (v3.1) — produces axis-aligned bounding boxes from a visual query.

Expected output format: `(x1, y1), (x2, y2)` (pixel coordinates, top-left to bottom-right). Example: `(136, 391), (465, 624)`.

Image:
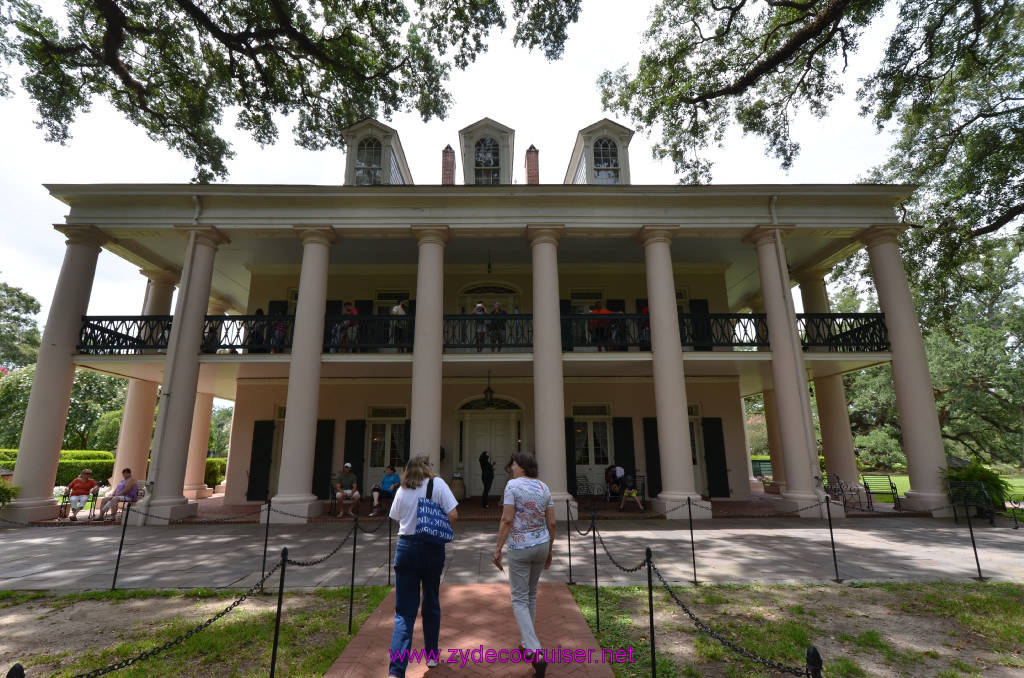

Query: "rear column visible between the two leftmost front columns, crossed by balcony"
(108, 270), (178, 486)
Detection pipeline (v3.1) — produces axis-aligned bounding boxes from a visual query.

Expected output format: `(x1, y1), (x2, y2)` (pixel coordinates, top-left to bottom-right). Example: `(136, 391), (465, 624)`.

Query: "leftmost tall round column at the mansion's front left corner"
(0, 226), (109, 522)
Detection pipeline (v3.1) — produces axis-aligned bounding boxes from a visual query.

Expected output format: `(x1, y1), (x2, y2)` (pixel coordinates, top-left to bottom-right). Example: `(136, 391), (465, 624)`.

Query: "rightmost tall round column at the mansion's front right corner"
(861, 227), (947, 510)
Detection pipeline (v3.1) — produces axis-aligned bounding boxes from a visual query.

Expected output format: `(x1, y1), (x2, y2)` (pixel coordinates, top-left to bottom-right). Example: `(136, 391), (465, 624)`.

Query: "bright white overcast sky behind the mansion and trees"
(0, 0), (889, 326)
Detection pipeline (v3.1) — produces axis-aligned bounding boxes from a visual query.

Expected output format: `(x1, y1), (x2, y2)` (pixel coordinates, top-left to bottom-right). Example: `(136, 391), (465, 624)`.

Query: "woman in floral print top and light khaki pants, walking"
(494, 452), (555, 678)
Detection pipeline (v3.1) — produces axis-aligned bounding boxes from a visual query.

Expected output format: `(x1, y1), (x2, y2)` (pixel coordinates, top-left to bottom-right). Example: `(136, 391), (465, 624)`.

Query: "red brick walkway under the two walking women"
(325, 582), (613, 678)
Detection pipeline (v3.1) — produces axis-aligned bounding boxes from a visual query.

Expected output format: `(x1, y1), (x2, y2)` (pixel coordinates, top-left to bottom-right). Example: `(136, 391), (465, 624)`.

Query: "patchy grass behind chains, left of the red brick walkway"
(0, 586), (390, 678)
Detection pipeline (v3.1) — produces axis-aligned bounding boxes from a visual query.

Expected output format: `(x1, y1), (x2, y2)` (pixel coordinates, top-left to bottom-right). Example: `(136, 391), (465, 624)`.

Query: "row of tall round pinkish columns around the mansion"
(4, 224), (944, 521)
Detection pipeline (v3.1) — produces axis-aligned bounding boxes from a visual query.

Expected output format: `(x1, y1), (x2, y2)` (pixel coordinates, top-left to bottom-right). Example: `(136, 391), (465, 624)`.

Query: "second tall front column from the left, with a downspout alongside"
(142, 226), (229, 523)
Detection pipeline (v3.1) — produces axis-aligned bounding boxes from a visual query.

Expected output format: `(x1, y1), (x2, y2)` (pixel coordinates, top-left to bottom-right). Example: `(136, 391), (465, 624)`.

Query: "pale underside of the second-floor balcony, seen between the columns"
(75, 351), (892, 400)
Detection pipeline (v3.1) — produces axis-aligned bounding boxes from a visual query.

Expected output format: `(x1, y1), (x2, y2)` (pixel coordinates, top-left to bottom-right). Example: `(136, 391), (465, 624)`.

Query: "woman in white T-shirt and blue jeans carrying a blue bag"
(388, 454), (459, 678)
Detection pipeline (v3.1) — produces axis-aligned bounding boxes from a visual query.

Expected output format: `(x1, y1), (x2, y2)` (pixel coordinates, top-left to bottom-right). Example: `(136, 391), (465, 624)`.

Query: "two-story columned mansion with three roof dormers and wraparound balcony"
(4, 119), (945, 519)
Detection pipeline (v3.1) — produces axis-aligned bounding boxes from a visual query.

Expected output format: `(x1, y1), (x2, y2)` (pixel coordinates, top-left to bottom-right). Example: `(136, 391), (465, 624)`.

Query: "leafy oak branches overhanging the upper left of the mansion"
(0, 0), (580, 181)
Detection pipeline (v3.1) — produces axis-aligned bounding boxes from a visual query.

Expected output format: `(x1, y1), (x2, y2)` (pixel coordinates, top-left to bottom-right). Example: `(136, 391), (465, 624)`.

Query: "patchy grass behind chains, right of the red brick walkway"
(571, 582), (1024, 678)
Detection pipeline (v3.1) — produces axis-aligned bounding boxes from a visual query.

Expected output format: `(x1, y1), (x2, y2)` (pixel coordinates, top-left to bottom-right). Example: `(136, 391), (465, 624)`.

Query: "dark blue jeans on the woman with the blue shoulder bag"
(388, 538), (444, 678)
